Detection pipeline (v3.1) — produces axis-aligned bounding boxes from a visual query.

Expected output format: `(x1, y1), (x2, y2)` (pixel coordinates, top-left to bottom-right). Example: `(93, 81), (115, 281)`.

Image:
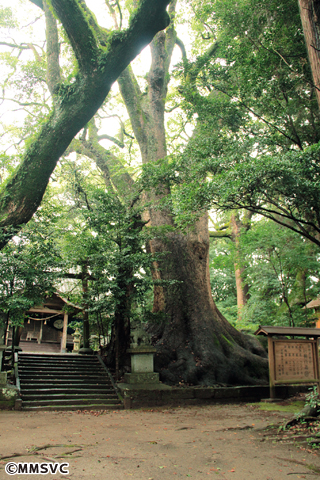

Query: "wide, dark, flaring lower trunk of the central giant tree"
(152, 212), (267, 385)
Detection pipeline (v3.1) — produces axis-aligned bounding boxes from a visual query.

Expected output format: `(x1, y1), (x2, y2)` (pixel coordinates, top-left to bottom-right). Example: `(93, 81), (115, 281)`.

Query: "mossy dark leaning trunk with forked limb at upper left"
(0, 0), (170, 248)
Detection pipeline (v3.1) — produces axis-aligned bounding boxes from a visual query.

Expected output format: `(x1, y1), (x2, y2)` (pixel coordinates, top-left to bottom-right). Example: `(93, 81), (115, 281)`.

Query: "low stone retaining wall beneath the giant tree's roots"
(118, 384), (310, 408)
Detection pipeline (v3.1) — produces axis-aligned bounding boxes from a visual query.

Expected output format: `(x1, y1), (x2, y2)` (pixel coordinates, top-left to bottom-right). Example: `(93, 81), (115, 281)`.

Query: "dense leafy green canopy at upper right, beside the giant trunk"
(138, 0), (319, 378)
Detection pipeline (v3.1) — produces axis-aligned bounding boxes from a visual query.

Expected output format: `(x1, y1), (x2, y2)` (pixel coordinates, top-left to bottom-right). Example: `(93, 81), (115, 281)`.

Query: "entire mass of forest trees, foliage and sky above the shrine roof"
(0, 0), (320, 384)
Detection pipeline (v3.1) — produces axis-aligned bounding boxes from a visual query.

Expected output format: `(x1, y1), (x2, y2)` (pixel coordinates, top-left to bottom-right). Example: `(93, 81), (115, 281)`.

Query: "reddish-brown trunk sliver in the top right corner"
(299, 0), (320, 108)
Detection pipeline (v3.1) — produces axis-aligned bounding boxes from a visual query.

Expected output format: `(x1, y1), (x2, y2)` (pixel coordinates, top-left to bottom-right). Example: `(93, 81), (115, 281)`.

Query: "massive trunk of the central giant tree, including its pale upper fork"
(118, 2), (267, 385)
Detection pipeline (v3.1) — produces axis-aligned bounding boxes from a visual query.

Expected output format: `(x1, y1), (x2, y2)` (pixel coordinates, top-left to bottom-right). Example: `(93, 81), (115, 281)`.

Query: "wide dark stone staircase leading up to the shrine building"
(18, 353), (123, 410)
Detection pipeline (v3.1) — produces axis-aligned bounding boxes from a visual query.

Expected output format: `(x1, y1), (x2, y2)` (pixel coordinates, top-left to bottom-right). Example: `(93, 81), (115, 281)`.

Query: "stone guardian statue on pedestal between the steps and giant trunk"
(124, 326), (159, 385)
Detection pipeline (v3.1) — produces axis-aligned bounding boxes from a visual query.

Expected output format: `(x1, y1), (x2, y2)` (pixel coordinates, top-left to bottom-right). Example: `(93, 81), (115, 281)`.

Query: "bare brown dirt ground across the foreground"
(0, 405), (320, 480)
